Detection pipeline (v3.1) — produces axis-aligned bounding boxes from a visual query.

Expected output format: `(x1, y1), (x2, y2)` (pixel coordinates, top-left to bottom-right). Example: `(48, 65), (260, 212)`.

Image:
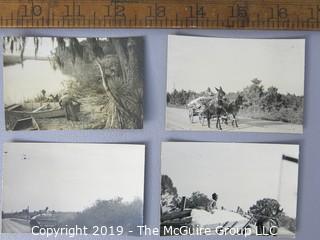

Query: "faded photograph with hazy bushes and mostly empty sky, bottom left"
(1, 143), (145, 235)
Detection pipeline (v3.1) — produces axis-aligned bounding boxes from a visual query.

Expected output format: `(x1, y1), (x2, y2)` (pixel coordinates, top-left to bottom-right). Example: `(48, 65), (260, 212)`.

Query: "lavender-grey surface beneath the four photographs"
(0, 29), (320, 240)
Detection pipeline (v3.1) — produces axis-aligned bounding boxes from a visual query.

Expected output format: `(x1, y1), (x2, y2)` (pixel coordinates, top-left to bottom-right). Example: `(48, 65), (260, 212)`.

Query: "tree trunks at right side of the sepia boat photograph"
(90, 38), (143, 128)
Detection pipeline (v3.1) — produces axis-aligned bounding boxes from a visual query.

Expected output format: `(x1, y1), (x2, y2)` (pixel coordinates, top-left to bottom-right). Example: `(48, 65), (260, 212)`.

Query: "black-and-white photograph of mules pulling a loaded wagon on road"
(166, 35), (305, 133)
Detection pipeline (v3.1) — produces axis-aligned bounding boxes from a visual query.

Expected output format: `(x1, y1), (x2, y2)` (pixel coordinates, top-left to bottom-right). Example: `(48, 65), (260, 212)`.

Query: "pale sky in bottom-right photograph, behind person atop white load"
(161, 142), (299, 218)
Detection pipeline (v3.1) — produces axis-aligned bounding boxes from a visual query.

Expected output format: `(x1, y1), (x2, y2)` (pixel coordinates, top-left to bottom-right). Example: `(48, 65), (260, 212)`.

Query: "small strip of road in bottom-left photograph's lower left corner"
(2, 218), (31, 233)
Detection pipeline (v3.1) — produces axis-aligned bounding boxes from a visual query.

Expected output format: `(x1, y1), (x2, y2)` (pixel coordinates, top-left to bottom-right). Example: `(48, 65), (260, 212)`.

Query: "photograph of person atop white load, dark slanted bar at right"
(161, 142), (299, 237)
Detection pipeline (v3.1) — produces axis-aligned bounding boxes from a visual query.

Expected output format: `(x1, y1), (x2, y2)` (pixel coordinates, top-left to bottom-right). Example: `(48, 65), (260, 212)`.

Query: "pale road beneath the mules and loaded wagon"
(166, 107), (303, 133)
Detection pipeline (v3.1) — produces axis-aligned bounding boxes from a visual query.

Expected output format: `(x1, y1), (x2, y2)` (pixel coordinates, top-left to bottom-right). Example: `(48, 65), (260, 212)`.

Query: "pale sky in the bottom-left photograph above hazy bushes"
(3, 143), (145, 212)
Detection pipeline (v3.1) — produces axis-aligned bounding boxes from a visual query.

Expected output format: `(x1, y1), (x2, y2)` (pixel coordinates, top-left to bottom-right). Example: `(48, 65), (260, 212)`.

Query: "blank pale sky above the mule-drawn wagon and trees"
(167, 35), (305, 95)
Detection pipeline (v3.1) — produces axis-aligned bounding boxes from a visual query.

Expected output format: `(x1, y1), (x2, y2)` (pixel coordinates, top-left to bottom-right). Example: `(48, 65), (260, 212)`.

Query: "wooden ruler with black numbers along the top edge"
(0, 0), (320, 30)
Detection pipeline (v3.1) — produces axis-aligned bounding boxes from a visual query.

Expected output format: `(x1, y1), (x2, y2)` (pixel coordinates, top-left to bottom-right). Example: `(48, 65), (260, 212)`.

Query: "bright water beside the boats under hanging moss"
(3, 60), (72, 105)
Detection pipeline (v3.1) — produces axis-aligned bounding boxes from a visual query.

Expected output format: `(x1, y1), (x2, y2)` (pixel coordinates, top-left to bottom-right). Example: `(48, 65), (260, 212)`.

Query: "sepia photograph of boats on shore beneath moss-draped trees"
(2, 36), (144, 131)
